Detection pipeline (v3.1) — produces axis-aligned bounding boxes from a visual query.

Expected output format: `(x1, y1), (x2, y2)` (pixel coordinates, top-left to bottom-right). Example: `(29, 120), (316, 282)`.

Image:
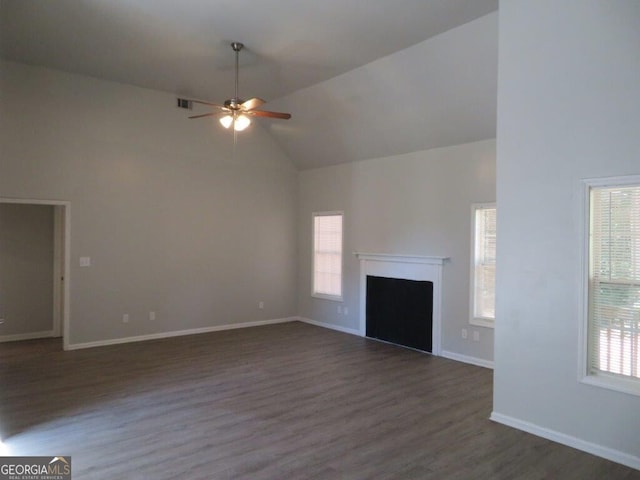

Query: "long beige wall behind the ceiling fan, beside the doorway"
(0, 62), (297, 344)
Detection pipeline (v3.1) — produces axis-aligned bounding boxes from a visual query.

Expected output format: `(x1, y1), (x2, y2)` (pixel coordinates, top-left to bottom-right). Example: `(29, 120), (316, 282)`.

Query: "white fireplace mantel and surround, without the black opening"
(355, 252), (449, 355)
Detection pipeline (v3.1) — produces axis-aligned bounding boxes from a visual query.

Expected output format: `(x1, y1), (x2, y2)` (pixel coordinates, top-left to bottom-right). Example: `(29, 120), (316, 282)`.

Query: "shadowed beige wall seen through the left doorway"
(0, 203), (53, 338)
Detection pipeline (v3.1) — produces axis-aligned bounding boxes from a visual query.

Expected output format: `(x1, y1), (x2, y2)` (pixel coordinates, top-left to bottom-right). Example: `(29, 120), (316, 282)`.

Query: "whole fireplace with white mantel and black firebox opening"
(356, 253), (447, 355)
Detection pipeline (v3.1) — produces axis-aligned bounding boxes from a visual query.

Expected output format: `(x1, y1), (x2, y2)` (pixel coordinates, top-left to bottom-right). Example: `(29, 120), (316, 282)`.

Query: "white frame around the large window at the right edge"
(578, 175), (640, 396)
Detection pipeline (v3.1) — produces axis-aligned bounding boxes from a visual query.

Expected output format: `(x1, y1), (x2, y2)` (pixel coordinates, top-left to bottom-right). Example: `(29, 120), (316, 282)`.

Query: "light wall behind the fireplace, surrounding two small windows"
(298, 140), (495, 361)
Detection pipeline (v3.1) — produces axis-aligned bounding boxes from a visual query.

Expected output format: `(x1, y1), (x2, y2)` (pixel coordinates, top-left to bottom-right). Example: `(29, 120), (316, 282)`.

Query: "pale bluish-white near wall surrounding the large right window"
(494, 0), (640, 468)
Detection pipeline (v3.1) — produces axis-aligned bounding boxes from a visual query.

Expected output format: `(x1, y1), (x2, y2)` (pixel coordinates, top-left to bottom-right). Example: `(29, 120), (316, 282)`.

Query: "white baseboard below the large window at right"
(490, 412), (640, 470)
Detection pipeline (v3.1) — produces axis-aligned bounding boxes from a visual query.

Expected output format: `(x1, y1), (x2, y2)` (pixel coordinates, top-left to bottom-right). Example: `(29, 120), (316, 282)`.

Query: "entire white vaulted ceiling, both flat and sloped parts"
(0, 0), (498, 168)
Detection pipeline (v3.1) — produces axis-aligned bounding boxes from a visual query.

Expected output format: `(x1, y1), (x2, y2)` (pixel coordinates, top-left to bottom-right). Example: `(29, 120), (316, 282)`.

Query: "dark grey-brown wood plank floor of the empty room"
(0, 322), (640, 480)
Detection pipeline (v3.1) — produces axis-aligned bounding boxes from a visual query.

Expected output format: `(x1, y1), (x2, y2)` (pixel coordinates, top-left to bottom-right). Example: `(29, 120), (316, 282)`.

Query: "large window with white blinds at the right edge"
(586, 176), (640, 393)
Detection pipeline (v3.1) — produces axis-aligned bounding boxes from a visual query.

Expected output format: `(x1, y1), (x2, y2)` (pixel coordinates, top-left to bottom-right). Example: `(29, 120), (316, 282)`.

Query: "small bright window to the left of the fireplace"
(312, 212), (343, 300)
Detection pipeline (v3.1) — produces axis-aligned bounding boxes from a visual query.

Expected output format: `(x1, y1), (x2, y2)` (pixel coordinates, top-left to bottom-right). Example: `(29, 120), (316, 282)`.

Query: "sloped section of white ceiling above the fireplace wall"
(265, 13), (498, 169)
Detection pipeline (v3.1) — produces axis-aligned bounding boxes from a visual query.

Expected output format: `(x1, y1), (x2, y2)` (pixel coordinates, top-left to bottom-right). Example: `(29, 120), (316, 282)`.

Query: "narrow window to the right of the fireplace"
(470, 203), (496, 327)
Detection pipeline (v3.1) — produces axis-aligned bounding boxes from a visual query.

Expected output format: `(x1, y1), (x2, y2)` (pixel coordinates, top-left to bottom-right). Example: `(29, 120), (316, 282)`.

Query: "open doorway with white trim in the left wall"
(0, 198), (70, 348)
